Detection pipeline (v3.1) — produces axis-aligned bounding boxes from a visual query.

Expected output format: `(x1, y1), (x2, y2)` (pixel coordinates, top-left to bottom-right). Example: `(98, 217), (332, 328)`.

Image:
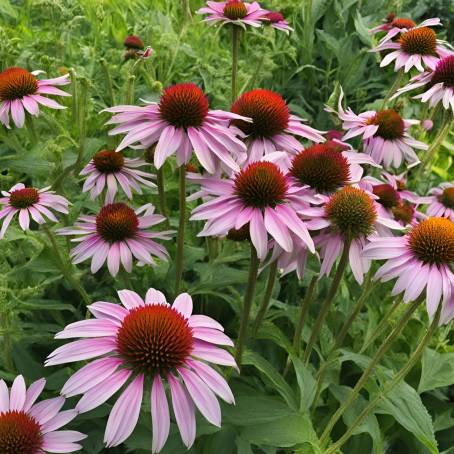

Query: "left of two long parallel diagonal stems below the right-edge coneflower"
(320, 297), (422, 446)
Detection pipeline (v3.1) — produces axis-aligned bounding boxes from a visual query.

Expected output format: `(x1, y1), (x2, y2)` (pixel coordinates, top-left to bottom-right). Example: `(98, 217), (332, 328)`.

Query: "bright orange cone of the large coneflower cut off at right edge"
(408, 218), (454, 264)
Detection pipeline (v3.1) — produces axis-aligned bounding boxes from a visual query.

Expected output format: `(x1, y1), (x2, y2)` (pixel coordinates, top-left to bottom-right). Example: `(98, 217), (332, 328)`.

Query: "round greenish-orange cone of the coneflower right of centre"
(325, 186), (377, 239)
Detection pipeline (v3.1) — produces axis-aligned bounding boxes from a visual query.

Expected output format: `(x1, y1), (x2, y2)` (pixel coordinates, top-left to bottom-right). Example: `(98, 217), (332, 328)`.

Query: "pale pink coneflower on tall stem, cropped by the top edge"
(197, 0), (268, 27)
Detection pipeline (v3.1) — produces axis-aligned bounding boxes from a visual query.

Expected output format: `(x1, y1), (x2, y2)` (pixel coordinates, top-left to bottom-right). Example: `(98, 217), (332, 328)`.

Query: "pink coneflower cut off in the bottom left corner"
(0, 375), (87, 454)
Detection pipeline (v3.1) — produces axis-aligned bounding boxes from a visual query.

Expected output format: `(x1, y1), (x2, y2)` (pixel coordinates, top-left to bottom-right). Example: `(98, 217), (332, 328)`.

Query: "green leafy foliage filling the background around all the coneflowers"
(0, 0), (454, 454)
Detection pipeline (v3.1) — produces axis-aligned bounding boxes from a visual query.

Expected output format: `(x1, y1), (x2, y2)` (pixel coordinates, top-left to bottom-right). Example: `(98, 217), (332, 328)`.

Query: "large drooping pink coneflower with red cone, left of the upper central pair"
(103, 83), (248, 173)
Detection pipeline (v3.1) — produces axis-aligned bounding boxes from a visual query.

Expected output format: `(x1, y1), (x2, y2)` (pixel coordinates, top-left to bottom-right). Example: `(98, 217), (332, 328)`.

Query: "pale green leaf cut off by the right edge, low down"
(418, 348), (454, 393)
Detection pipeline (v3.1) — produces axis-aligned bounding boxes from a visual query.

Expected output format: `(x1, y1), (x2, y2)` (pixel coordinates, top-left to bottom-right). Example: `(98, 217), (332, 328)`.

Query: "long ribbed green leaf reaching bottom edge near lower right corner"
(376, 382), (439, 453)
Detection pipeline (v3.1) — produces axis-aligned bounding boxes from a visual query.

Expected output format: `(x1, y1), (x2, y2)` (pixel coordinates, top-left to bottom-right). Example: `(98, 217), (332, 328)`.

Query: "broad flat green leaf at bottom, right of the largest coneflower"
(241, 414), (318, 448)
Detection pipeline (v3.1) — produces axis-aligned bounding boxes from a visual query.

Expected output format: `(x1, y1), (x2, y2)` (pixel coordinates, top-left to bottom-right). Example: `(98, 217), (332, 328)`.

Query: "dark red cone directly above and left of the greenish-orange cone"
(290, 144), (350, 194)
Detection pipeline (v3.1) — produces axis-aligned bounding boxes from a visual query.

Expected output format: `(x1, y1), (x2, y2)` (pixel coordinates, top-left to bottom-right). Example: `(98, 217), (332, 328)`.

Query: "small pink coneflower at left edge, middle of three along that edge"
(0, 183), (69, 238)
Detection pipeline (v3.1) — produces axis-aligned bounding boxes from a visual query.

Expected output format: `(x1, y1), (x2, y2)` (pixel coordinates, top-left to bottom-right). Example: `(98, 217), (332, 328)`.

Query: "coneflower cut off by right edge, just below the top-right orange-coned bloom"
(391, 55), (454, 113)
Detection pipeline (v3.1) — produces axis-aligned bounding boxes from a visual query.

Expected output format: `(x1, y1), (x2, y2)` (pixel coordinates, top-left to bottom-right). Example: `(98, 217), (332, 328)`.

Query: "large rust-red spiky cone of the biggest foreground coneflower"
(117, 304), (193, 376)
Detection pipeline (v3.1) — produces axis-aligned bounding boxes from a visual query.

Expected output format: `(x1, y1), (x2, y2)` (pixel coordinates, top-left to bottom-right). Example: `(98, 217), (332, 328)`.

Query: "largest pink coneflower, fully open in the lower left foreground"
(46, 288), (236, 453)
